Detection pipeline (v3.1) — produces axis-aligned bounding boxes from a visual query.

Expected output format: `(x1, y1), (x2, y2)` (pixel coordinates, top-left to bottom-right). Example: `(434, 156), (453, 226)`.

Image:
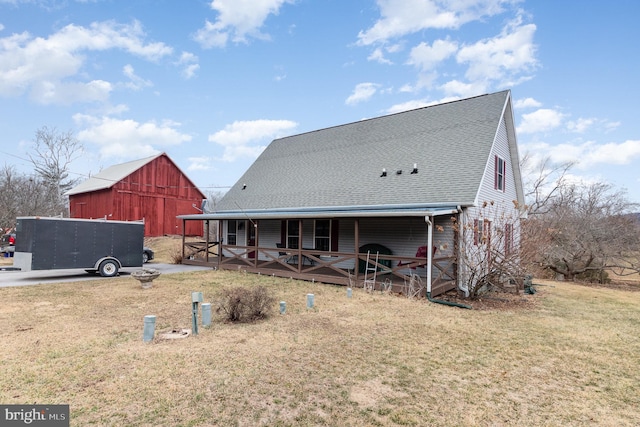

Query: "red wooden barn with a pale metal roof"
(66, 153), (205, 237)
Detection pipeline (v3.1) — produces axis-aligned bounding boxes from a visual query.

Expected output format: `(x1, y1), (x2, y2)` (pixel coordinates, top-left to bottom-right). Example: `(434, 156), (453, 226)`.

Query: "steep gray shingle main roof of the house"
(216, 91), (510, 212)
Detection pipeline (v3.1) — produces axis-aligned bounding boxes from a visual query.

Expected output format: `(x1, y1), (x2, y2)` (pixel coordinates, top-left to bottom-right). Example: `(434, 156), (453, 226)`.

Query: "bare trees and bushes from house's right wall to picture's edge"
(460, 156), (640, 298)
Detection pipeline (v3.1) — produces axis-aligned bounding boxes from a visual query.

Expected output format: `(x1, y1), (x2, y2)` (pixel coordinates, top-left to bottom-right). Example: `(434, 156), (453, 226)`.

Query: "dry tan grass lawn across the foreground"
(0, 254), (640, 426)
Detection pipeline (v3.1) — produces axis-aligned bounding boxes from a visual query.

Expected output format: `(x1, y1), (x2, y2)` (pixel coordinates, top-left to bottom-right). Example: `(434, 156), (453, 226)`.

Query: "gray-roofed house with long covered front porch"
(180, 91), (524, 296)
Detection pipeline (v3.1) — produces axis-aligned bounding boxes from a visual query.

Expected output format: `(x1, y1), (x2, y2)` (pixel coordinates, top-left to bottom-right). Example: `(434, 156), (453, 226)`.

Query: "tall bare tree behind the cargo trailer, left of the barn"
(29, 126), (83, 215)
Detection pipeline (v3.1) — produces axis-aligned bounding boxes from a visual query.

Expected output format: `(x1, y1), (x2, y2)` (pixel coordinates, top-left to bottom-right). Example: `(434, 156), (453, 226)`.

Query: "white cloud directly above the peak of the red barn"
(73, 114), (191, 160)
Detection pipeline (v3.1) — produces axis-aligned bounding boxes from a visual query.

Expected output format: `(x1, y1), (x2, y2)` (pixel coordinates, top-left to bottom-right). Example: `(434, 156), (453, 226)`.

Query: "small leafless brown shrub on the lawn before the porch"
(216, 286), (275, 322)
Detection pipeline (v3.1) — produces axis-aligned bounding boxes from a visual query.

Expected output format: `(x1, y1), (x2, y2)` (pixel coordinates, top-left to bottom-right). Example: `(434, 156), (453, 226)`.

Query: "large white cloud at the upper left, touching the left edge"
(0, 21), (172, 104)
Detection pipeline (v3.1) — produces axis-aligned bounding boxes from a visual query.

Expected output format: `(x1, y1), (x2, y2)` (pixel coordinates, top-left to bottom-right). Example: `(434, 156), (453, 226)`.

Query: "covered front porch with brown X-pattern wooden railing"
(181, 208), (459, 296)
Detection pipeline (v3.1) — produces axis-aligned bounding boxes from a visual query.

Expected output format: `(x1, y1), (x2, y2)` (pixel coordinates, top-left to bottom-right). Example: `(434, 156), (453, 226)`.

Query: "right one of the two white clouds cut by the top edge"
(358, 0), (513, 46)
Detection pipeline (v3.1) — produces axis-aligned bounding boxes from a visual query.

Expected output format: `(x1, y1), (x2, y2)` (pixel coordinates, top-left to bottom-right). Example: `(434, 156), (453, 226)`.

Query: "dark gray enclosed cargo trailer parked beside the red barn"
(13, 217), (144, 277)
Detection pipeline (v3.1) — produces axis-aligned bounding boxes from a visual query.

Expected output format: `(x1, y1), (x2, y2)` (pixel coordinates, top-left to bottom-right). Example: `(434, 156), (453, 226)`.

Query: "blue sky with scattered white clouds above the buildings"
(0, 0), (640, 203)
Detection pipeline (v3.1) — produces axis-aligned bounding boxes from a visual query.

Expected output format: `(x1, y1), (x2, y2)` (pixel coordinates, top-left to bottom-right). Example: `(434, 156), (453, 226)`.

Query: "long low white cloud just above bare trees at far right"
(521, 140), (640, 170)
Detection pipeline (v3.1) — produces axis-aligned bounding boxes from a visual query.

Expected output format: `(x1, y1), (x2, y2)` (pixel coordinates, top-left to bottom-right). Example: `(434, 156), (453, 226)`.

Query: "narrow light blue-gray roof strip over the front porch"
(178, 205), (460, 220)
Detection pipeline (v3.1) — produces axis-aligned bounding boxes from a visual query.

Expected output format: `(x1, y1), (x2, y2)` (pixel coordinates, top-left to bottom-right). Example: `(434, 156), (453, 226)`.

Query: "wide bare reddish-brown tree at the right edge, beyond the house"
(523, 183), (640, 280)
